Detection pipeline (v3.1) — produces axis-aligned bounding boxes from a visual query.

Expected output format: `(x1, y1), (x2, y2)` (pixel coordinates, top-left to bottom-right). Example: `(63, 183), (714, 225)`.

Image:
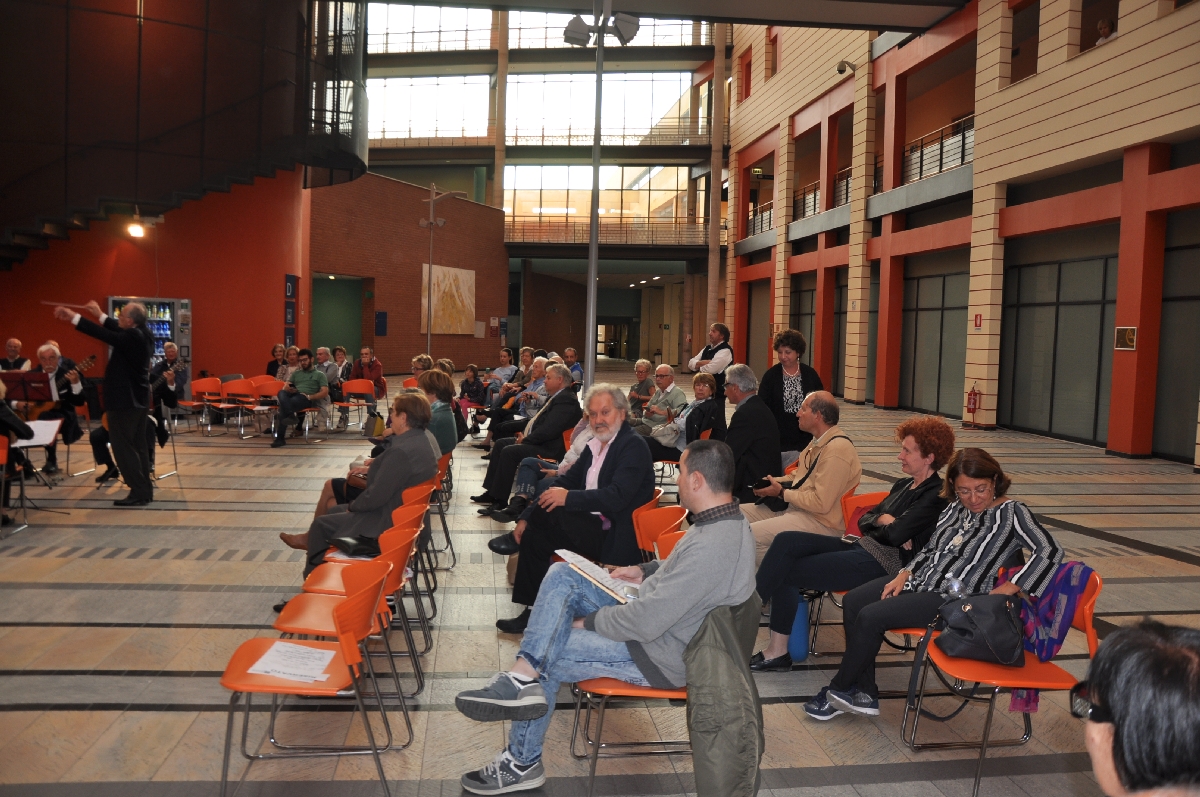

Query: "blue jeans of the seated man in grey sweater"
(509, 562), (650, 766)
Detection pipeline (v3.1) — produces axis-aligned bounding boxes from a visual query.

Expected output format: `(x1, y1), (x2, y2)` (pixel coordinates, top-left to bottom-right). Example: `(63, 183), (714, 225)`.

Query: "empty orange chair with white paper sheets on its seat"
(221, 566), (400, 797)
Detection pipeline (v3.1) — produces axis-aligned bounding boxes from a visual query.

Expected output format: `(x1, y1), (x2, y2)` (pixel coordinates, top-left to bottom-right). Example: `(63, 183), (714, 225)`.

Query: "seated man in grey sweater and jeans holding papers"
(455, 441), (755, 795)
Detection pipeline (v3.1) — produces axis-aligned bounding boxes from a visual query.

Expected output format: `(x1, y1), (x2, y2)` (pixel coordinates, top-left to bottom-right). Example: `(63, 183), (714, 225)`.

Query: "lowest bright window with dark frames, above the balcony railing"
(504, 166), (688, 222)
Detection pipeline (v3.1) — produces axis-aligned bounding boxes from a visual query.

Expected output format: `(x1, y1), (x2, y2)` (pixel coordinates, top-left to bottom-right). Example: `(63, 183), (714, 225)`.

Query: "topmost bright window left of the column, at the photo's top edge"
(367, 2), (492, 53)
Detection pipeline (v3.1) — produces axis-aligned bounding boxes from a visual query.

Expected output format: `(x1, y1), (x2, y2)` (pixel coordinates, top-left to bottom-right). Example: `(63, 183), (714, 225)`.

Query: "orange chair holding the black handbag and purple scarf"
(900, 571), (1104, 797)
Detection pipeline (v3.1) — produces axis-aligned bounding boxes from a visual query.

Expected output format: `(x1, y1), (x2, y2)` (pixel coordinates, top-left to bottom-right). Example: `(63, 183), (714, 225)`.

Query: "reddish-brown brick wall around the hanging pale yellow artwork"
(310, 174), (508, 373)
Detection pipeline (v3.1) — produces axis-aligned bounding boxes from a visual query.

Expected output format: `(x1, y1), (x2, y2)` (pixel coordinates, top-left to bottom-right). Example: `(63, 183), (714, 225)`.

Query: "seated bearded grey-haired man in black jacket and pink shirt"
(496, 384), (654, 634)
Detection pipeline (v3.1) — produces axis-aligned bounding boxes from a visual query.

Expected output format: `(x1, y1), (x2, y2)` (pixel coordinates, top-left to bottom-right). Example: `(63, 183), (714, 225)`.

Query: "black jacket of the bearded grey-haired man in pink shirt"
(554, 422), (657, 565)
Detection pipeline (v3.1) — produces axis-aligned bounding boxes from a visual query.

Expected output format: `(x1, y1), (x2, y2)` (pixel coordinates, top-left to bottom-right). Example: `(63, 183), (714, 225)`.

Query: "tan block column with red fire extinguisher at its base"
(962, 184), (1008, 427)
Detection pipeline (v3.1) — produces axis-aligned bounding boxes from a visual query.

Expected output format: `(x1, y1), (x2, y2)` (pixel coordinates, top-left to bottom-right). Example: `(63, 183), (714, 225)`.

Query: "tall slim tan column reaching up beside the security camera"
(842, 35), (875, 403)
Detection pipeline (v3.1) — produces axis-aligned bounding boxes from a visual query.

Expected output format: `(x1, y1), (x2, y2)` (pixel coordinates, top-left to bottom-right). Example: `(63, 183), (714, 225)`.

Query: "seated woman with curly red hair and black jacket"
(750, 415), (954, 672)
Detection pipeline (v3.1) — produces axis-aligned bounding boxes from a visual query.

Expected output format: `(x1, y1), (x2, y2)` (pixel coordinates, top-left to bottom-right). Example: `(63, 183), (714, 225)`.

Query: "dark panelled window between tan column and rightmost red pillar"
(998, 257), (1113, 443)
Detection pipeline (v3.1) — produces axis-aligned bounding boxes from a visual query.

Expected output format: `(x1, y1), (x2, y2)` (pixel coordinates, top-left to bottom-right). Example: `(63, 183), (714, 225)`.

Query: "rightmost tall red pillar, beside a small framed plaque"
(1108, 144), (1171, 456)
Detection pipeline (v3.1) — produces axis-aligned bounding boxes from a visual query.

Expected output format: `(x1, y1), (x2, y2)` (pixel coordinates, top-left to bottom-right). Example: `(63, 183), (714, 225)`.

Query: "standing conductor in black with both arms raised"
(54, 301), (154, 507)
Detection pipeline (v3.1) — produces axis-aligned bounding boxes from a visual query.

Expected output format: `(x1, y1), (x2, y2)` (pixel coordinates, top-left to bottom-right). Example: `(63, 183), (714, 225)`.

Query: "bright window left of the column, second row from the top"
(367, 74), (491, 138)
